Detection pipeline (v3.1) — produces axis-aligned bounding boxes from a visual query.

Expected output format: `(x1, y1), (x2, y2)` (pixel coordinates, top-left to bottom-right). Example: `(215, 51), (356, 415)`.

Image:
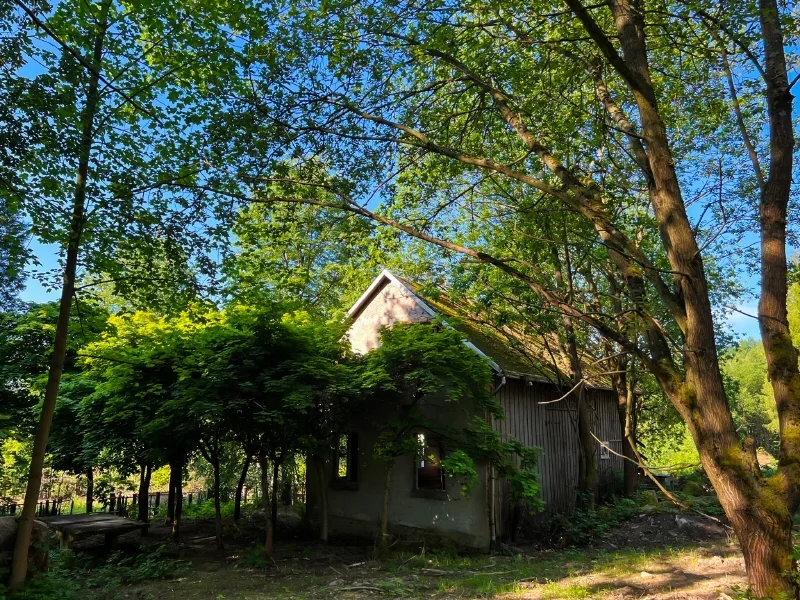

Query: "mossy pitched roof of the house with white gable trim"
(347, 269), (607, 388)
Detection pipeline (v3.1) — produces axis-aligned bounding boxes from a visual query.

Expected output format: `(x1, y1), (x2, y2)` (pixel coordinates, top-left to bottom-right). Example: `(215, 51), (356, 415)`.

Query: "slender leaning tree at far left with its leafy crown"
(3, 0), (253, 592)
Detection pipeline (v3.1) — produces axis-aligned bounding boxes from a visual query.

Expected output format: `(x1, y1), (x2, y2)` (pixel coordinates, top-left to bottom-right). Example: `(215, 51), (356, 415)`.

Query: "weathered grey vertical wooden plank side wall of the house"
(494, 378), (623, 535)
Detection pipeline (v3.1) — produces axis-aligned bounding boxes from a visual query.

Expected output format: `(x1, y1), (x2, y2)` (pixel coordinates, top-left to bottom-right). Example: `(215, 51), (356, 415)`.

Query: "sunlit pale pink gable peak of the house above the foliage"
(347, 278), (430, 354)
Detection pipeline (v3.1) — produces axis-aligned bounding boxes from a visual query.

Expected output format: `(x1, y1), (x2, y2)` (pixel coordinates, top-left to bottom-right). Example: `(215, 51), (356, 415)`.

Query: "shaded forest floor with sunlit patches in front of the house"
(23, 512), (745, 600)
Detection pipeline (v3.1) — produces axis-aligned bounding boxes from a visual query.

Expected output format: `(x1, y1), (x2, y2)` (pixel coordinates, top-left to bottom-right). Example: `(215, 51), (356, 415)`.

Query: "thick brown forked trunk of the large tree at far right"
(567, 0), (800, 597)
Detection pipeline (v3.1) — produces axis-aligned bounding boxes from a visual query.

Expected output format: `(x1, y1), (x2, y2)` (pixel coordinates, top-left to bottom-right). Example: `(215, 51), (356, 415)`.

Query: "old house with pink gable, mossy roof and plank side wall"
(307, 271), (623, 549)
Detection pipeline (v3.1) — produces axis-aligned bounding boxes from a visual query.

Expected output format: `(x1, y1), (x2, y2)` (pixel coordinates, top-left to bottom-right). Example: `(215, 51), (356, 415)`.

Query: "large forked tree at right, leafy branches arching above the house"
(189, 0), (800, 595)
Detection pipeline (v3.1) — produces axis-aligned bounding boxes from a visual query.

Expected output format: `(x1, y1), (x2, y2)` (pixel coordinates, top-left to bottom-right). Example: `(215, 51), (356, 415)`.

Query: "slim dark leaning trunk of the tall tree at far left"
(8, 0), (111, 595)
